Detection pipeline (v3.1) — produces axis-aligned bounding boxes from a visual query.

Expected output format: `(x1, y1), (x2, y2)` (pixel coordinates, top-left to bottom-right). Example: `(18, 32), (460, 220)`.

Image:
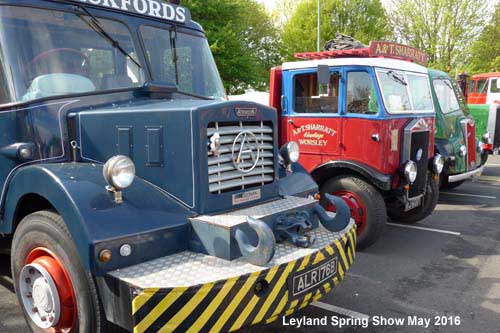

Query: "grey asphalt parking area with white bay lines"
(0, 156), (500, 333)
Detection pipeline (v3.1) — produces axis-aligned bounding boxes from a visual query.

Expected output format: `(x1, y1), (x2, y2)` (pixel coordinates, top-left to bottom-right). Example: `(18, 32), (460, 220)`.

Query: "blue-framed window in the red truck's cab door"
(347, 72), (379, 114)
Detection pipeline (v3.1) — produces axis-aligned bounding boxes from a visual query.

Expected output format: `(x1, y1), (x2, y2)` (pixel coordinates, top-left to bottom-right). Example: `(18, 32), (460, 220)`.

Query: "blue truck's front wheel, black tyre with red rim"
(11, 211), (113, 333)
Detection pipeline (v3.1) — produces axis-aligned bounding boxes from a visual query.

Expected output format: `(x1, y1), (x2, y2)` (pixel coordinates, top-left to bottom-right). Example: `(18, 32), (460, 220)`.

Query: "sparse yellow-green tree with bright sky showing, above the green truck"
(390, 0), (487, 71)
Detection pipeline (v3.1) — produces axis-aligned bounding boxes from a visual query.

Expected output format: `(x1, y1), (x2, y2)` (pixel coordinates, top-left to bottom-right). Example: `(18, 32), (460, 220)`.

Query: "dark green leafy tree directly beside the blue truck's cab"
(183, 0), (281, 94)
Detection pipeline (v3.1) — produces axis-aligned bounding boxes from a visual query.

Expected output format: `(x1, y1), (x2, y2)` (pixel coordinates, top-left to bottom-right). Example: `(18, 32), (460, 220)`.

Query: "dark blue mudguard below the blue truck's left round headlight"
(0, 163), (194, 276)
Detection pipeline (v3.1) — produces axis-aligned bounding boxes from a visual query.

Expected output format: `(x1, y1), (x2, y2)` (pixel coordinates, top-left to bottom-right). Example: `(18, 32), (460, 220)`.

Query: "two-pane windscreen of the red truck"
(377, 69), (434, 113)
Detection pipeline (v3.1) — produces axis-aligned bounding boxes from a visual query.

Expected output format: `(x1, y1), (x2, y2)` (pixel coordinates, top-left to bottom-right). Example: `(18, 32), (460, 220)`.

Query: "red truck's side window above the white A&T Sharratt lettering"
(294, 72), (340, 113)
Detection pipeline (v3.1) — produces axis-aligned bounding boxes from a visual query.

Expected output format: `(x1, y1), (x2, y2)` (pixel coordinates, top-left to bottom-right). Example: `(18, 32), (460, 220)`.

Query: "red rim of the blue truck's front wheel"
(21, 247), (77, 333)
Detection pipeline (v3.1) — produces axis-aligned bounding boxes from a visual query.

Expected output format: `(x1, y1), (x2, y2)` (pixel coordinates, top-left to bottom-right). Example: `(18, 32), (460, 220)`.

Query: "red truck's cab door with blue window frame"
(342, 66), (388, 171)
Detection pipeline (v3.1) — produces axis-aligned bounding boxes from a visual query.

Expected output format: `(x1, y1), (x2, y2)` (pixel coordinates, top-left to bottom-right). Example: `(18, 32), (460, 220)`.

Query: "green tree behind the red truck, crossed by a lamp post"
(281, 0), (392, 60)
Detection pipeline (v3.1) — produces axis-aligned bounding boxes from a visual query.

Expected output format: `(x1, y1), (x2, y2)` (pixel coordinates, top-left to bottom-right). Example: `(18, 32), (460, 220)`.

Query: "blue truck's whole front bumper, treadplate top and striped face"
(106, 221), (356, 333)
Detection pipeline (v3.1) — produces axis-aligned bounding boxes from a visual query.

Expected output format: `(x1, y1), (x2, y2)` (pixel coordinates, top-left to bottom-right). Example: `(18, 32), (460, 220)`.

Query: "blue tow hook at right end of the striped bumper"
(313, 193), (351, 232)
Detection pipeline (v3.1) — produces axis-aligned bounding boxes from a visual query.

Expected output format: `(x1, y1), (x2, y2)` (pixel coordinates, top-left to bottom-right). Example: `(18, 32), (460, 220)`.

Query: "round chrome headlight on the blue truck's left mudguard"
(102, 155), (135, 191)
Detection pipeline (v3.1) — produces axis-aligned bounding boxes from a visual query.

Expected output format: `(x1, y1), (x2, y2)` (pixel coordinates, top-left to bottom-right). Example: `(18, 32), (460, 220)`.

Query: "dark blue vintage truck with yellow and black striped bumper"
(0, 0), (356, 333)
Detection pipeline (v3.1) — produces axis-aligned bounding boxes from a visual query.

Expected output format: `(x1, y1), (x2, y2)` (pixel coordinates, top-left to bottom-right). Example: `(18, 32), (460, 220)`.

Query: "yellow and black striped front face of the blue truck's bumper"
(107, 224), (356, 333)
